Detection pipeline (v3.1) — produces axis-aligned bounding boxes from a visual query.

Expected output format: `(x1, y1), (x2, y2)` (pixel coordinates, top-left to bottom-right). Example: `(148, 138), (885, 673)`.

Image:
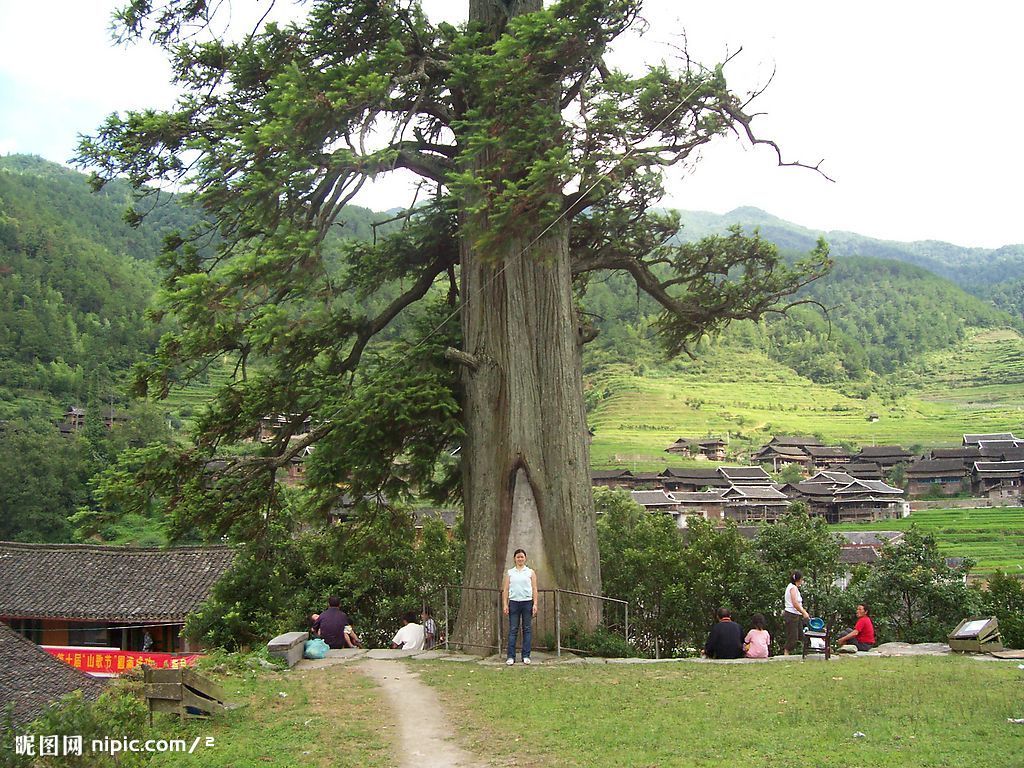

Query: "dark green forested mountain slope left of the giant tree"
(0, 155), (383, 418)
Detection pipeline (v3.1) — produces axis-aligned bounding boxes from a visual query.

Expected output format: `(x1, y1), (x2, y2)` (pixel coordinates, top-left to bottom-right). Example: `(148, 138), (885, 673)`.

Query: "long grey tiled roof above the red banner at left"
(0, 542), (234, 622)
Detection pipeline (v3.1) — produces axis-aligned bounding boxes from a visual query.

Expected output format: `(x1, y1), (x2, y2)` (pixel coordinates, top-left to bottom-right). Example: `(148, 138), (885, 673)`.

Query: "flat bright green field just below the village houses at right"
(834, 507), (1024, 574)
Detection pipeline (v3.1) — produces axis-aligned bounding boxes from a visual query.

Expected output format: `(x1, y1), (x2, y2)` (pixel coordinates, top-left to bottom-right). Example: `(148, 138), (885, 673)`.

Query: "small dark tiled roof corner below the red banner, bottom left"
(0, 622), (103, 725)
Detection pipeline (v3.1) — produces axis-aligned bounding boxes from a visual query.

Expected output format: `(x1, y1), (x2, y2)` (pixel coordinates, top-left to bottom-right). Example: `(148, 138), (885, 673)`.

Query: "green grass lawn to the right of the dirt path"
(417, 657), (1024, 768)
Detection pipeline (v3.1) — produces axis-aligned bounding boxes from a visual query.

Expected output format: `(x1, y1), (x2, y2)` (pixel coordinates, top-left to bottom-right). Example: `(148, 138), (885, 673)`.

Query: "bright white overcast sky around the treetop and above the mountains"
(0, 0), (1024, 247)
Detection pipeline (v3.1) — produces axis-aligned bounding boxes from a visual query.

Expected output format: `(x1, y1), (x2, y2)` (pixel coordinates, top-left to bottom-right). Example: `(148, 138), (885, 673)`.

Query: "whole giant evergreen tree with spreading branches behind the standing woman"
(80, 0), (826, 646)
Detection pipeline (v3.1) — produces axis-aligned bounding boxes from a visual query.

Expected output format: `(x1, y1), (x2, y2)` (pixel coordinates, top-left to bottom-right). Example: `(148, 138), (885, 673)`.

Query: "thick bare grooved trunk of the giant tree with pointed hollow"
(455, 222), (601, 652)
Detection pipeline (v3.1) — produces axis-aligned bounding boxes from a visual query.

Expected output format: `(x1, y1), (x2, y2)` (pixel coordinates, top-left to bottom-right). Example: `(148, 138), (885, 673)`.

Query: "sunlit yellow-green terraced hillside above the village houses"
(587, 331), (1024, 470)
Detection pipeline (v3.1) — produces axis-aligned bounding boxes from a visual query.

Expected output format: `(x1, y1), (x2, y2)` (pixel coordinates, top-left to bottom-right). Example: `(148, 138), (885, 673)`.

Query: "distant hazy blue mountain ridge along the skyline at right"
(680, 207), (1024, 295)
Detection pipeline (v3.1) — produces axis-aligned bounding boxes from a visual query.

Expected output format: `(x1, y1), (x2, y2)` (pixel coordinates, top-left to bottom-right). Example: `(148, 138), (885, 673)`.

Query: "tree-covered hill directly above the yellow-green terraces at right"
(586, 252), (1013, 383)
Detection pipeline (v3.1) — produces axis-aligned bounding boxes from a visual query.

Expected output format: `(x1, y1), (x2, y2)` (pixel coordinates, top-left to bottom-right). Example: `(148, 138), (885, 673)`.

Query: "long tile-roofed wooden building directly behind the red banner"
(0, 542), (234, 653)
